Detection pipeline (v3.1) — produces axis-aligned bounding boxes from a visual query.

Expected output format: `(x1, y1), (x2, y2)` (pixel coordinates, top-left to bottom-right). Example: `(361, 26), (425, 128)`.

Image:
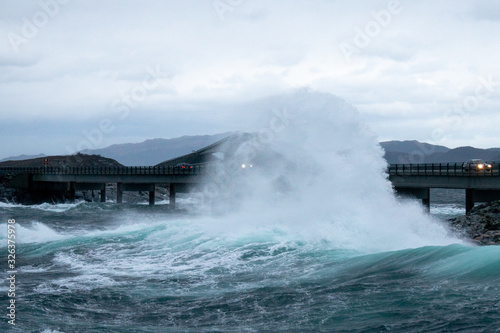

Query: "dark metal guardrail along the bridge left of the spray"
(0, 165), (207, 175)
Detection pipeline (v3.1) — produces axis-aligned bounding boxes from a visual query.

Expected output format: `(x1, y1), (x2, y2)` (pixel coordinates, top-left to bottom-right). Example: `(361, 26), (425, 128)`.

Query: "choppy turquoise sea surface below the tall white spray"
(0, 203), (500, 332)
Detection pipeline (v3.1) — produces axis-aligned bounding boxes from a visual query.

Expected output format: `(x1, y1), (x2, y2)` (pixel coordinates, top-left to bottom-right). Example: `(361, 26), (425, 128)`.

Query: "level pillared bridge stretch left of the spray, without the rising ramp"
(0, 165), (209, 209)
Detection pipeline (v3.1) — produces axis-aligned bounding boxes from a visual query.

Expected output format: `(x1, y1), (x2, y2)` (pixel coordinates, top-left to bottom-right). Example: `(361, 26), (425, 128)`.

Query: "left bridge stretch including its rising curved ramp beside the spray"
(0, 133), (254, 209)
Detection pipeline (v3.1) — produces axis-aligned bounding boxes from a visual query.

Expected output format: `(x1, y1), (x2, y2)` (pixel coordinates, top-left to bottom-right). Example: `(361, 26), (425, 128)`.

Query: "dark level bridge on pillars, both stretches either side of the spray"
(0, 163), (500, 214)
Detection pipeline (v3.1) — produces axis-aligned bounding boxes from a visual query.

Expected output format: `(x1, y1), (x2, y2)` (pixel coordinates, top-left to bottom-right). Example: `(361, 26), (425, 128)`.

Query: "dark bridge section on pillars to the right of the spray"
(387, 163), (500, 214)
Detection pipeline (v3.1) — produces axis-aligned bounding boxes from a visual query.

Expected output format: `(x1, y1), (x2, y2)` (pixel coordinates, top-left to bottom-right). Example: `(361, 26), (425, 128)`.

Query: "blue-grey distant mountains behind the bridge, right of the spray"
(380, 141), (500, 164)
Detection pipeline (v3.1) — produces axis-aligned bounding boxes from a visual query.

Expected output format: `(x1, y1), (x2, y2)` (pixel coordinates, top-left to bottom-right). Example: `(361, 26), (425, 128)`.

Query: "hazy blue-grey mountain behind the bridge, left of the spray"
(81, 132), (232, 166)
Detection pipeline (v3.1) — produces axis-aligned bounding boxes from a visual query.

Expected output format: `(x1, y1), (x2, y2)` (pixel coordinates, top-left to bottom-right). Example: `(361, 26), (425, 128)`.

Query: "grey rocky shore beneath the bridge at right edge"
(448, 201), (500, 245)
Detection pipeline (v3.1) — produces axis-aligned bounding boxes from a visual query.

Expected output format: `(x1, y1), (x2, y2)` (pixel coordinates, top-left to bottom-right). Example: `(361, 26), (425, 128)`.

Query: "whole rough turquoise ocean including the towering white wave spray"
(0, 92), (500, 333)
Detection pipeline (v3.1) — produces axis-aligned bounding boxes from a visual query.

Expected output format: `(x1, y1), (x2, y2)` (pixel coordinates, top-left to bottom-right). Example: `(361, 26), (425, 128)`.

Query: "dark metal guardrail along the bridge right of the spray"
(387, 163), (500, 177)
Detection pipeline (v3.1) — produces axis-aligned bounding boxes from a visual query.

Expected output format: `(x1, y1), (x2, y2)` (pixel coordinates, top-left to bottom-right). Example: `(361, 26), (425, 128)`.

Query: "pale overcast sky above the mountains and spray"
(0, 0), (500, 158)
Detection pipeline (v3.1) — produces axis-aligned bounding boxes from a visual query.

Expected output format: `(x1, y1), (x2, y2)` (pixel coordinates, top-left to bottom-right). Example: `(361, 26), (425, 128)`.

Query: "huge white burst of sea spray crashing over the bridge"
(198, 91), (460, 251)
